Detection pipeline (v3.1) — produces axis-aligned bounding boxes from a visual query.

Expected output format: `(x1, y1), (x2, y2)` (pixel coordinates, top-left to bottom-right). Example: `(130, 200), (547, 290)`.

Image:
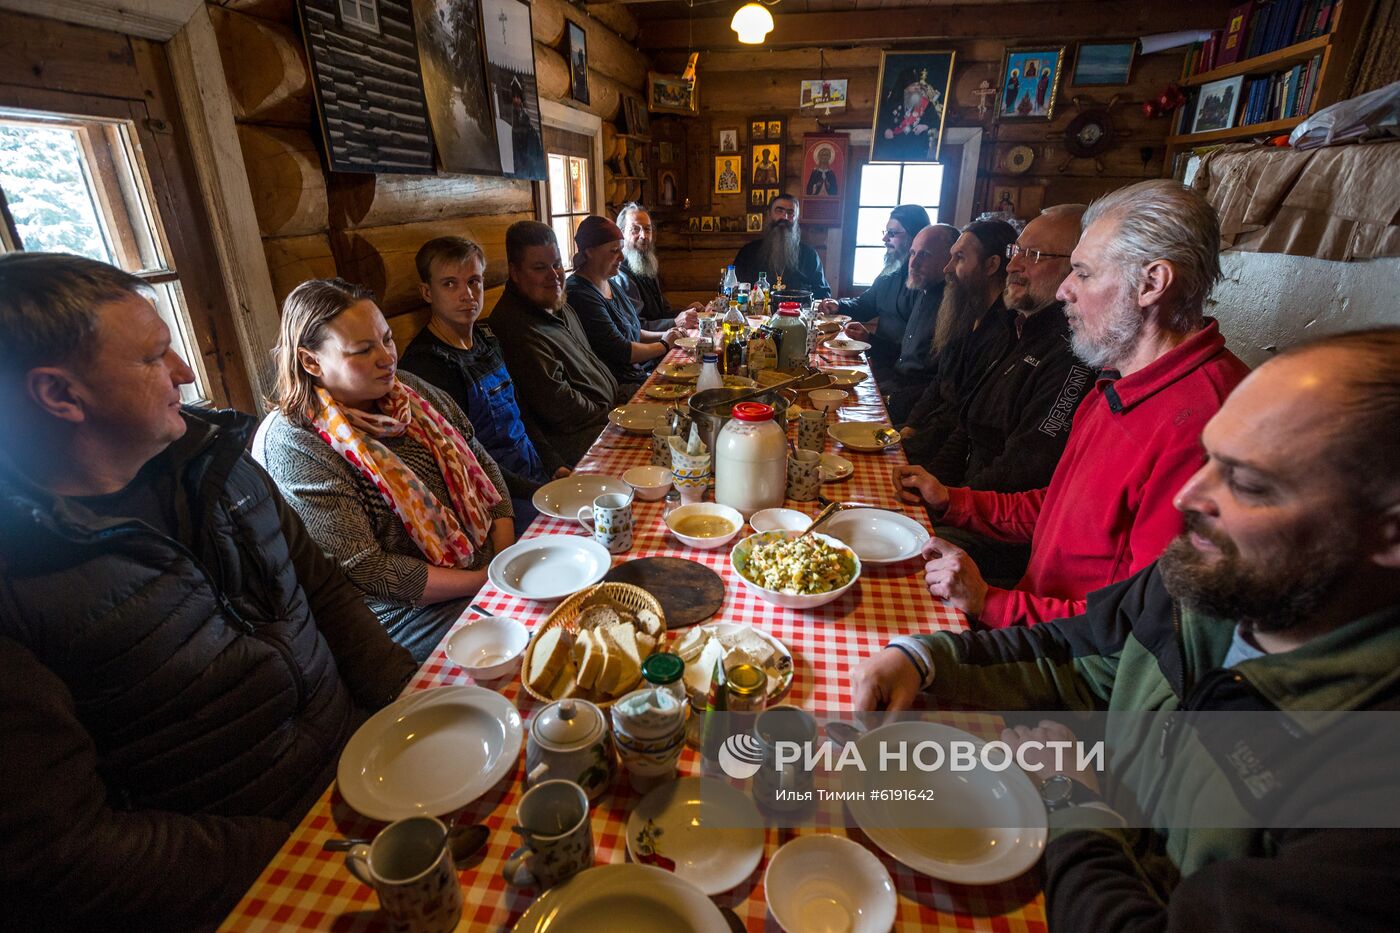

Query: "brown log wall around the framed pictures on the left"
(209, 0), (647, 347)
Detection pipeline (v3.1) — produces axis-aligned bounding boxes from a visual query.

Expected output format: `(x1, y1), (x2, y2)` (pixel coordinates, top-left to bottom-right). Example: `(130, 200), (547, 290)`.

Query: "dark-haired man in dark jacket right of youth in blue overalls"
(490, 220), (629, 467)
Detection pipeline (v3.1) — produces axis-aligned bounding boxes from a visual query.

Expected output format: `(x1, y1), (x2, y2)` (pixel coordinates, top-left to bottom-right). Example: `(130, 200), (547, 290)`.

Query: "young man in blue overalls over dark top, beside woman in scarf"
(399, 237), (571, 537)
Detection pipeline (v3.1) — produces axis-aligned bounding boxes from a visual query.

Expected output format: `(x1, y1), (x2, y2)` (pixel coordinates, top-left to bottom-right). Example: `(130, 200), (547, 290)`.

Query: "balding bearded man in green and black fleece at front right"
(854, 328), (1400, 933)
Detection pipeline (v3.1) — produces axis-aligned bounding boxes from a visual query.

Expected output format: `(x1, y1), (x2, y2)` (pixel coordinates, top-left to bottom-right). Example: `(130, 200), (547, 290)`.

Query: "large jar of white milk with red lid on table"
(714, 402), (788, 520)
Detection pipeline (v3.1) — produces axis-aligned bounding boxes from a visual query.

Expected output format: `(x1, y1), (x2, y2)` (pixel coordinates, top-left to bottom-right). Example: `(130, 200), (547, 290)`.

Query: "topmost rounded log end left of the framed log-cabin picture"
(209, 7), (312, 126)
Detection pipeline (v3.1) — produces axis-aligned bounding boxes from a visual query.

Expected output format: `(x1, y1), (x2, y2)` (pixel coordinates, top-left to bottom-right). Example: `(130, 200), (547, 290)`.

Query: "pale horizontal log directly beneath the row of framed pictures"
(328, 172), (533, 230)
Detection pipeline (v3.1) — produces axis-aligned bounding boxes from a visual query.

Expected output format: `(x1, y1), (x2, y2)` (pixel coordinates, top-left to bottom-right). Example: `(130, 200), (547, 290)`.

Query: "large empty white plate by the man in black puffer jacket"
(336, 685), (522, 822)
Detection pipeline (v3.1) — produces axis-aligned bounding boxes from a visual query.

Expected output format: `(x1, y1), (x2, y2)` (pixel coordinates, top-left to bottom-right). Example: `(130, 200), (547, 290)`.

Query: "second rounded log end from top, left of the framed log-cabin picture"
(238, 123), (328, 237)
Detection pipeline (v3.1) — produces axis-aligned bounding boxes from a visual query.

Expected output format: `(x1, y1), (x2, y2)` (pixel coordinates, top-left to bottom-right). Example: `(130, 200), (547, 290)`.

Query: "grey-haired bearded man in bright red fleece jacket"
(895, 179), (1249, 628)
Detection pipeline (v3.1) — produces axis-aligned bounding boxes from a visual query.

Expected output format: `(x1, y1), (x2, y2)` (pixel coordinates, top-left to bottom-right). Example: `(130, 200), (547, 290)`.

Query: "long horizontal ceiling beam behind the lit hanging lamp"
(638, 0), (1221, 52)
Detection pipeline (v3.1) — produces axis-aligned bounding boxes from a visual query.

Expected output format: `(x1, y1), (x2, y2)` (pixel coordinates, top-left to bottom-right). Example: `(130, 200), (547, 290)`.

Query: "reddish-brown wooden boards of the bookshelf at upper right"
(1166, 0), (1366, 162)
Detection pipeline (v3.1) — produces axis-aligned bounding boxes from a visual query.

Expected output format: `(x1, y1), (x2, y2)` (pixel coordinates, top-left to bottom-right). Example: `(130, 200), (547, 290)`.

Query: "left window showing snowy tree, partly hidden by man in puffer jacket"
(0, 109), (209, 402)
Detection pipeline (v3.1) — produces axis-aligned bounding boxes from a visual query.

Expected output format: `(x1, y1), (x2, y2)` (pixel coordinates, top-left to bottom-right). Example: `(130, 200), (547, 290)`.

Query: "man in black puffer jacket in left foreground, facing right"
(0, 252), (413, 929)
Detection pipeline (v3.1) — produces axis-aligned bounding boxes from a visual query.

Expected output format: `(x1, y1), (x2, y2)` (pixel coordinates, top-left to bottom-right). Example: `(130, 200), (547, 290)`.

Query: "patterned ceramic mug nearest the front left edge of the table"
(346, 817), (462, 933)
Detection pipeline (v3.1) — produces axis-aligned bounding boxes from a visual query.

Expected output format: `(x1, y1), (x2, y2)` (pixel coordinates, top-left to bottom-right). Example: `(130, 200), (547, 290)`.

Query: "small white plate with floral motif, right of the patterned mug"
(630, 778), (763, 896)
